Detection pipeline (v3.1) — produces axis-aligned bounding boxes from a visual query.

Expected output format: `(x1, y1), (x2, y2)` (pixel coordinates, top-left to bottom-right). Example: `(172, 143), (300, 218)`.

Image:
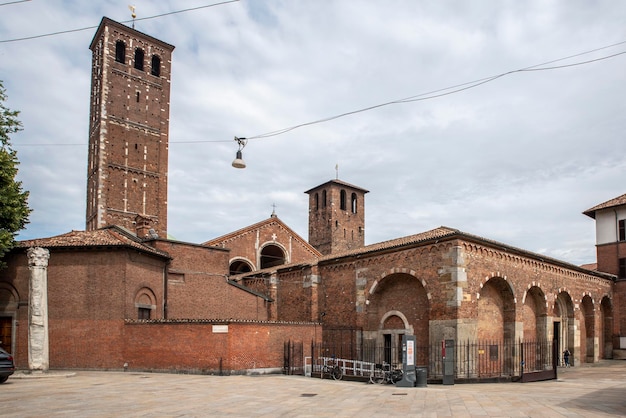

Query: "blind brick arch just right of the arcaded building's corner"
(478, 277), (515, 342)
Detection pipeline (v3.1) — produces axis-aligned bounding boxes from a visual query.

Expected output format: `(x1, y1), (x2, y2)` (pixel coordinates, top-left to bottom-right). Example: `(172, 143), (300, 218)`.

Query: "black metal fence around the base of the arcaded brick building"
(304, 334), (557, 381)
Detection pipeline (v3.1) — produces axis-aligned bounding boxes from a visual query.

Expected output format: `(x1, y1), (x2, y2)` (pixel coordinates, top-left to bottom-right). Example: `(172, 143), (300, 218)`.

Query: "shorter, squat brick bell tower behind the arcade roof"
(305, 179), (368, 255)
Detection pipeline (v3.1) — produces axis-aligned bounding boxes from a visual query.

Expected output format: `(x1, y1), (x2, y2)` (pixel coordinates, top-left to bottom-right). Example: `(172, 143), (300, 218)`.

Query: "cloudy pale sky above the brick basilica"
(0, 0), (626, 265)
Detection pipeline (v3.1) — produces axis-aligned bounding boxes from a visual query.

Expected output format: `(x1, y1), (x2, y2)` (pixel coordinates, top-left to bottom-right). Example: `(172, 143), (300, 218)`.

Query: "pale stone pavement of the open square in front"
(0, 360), (626, 417)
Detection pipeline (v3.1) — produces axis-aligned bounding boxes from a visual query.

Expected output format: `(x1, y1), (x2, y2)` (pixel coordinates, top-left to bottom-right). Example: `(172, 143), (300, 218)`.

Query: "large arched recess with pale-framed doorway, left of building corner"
(363, 273), (430, 364)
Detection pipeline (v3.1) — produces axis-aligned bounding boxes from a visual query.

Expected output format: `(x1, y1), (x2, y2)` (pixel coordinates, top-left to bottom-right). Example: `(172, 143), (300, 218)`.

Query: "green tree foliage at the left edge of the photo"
(0, 80), (31, 268)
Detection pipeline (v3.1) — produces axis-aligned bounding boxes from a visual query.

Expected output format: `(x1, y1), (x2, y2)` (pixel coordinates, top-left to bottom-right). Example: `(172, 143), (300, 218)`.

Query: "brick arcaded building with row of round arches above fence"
(277, 238), (613, 362)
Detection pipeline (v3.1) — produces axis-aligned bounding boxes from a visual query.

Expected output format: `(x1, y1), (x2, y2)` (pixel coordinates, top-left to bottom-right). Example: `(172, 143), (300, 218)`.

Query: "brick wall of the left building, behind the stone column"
(0, 248), (165, 368)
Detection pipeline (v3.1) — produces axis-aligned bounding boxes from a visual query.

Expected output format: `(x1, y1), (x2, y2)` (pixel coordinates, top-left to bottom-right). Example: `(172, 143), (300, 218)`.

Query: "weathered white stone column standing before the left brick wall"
(27, 247), (50, 372)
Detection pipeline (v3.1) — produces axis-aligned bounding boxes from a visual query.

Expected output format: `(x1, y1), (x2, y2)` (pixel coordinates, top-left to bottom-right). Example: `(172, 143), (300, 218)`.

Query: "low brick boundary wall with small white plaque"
(124, 322), (315, 374)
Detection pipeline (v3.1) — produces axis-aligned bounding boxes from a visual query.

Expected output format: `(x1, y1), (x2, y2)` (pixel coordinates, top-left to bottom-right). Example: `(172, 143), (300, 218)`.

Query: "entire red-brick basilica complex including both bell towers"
(0, 18), (626, 373)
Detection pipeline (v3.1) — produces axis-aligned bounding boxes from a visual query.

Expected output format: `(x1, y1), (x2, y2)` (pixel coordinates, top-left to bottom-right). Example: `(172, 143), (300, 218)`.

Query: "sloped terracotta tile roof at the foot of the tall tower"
(17, 226), (171, 258)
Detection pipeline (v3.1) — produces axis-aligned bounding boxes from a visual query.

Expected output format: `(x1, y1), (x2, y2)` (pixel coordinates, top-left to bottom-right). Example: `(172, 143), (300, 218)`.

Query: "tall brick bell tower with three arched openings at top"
(86, 17), (174, 238)
